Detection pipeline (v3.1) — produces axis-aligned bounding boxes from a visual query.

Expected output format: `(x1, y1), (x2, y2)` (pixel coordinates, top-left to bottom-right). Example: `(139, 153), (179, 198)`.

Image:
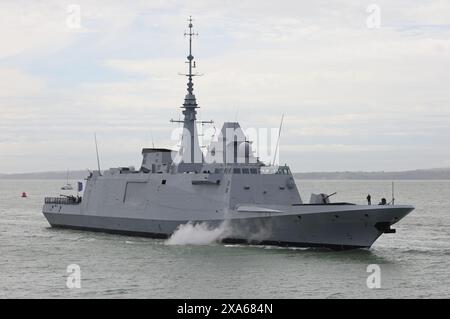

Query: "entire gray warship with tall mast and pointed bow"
(43, 19), (414, 250)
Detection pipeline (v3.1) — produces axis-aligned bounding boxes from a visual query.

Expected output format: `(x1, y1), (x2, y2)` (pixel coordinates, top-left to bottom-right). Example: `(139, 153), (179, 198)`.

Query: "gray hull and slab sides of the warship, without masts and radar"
(43, 168), (413, 248)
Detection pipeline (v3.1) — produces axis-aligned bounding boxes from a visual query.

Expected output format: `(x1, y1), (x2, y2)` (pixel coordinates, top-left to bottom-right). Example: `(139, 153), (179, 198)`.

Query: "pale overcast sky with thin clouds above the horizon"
(0, 0), (450, 173)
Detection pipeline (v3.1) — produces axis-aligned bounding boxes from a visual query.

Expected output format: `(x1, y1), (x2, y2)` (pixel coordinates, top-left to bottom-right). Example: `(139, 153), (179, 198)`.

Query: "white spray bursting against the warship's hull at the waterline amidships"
(166, 221), (229, 245)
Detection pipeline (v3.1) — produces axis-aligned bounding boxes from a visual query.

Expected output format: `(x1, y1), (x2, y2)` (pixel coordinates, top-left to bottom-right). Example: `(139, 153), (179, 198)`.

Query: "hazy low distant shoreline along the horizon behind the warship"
(0, 168), (450, 180)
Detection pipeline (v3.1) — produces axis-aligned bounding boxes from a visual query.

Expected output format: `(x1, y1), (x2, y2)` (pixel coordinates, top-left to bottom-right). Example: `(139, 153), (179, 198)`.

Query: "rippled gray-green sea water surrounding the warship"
(0, 180), (450, 298)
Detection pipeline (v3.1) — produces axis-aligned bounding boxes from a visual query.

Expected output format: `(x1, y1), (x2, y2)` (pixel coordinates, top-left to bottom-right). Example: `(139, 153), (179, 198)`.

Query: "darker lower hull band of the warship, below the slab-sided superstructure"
(44, 205), (413, 249)
